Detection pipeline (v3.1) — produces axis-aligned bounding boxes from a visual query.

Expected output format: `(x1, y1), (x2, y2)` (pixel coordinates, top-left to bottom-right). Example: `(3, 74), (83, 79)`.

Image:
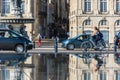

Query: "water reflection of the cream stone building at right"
(69, 54), (120, 80)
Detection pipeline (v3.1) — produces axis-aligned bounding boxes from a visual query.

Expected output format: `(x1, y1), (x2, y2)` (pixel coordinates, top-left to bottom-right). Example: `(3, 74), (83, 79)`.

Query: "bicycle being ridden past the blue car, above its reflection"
(81, 38), (109, 51)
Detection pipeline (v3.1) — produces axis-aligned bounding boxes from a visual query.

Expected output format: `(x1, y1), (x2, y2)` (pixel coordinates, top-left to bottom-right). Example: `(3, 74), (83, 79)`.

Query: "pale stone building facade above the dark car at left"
(0, 0), (34, 38)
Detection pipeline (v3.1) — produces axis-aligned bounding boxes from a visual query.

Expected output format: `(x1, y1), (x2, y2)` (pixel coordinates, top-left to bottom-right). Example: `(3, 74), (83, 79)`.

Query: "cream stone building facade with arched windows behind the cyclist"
(69, 0), (120, 43)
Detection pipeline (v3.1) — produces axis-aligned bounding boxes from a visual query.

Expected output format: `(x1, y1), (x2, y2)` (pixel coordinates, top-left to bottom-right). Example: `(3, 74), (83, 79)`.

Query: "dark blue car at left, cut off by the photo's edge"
(0, 29), (33, 53)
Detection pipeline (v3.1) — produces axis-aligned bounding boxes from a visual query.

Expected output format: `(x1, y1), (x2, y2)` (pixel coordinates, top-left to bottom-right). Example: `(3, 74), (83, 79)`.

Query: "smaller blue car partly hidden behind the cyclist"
(62, 34), (90, 50)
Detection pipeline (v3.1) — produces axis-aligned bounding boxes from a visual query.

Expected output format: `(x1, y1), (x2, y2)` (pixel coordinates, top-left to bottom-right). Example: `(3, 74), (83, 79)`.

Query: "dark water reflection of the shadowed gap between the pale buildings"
(34, 54), (68, 80)
